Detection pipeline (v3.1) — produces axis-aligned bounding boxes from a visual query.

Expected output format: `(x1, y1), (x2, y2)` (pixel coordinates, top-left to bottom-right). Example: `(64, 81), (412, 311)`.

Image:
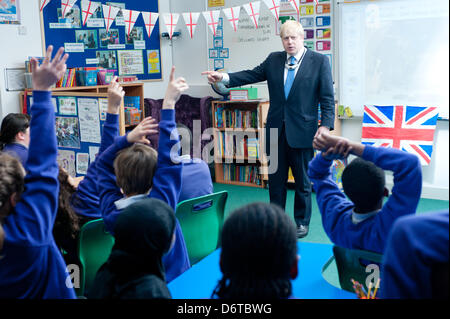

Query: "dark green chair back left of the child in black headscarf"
(77, 219), (114, 296)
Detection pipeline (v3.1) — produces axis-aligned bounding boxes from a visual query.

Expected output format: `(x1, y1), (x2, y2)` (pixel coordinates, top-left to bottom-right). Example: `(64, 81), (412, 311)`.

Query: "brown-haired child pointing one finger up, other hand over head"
(97, 68), (190, 282)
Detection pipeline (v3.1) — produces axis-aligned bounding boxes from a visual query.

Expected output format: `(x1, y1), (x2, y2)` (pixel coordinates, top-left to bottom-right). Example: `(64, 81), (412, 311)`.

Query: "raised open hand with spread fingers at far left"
(30, 45), (69, 91)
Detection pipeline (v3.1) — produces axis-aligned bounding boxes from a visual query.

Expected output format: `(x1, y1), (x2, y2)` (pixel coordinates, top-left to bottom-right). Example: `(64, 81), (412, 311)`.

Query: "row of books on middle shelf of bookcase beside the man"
(216, 132), (260, 159)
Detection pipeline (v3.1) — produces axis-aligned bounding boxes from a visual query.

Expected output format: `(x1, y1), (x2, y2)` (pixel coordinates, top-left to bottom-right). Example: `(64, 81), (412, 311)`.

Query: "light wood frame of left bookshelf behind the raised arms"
(20, 82), (145, 135)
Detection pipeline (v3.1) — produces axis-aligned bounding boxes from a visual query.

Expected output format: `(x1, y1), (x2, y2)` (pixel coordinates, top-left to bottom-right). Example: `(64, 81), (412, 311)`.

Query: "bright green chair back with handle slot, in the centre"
(176, 191), (228, 265)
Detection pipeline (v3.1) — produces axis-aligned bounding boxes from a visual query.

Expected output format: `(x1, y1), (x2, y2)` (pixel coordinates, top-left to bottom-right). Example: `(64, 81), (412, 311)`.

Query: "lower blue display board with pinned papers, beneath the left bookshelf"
(26, 92), (115, 177)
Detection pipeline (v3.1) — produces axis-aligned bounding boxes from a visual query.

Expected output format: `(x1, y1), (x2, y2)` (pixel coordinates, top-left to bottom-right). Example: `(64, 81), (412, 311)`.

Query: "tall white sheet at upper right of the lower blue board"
(78, 98), (101, 144)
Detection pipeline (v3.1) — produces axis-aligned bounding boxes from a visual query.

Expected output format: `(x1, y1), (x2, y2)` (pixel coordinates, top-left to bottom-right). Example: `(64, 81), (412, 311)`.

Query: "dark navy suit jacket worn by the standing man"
(228, 50), (334, 154)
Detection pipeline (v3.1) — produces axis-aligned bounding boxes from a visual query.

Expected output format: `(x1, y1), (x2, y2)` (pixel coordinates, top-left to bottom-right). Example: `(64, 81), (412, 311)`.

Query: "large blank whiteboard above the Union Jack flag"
(336, 0), (449, 119)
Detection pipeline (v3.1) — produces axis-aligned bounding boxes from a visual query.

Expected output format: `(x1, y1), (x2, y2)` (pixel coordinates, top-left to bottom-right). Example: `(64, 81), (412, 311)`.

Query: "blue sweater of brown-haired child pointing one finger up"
(97, 110), (190, 282)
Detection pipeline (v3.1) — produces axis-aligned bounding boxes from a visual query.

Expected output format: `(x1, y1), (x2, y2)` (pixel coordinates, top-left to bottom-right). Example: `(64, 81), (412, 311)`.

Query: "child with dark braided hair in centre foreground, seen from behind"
(212, 203), (299, 300)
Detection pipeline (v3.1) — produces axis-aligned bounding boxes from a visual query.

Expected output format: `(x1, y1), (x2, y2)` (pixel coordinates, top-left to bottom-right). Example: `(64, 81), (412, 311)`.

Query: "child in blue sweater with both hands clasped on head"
(308, 133), (422, 254)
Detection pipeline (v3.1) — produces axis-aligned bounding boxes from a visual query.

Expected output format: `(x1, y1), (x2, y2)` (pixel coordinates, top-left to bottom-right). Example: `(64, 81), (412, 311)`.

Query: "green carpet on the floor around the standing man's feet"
(214, 183), (449, 287)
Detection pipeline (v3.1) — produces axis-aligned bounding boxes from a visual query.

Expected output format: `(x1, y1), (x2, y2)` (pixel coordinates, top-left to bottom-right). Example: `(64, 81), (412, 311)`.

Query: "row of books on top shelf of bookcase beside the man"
(214, 106), (258, 128)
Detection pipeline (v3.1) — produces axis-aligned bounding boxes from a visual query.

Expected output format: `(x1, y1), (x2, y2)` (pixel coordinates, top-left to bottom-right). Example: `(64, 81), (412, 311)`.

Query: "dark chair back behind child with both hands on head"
(333, 245), (383, 292)
